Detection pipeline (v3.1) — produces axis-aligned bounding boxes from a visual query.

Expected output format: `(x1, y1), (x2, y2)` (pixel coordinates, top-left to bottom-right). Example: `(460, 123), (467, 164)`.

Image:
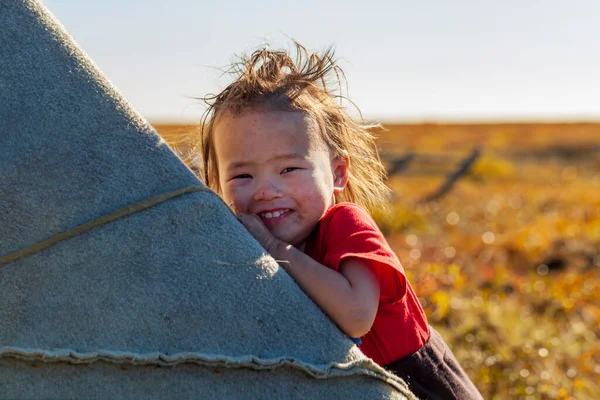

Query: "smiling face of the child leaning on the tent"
(213, 110), (348, 247)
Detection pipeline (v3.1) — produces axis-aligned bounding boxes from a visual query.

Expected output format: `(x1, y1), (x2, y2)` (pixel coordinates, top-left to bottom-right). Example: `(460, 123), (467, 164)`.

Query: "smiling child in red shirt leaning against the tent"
(201, 44), (481, 399)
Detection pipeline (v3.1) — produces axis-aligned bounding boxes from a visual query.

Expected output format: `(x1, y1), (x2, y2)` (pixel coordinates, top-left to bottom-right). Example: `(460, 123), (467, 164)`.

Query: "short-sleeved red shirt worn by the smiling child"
(304, 203), (429, 365)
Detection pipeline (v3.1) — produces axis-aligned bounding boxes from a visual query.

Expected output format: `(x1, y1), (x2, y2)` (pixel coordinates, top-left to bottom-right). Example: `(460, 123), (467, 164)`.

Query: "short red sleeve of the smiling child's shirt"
(319, 203), (406, 307)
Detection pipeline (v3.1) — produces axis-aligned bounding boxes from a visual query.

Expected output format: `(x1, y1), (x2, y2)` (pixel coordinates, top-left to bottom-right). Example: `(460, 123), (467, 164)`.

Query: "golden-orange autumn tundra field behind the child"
(155, 123), (600, 399)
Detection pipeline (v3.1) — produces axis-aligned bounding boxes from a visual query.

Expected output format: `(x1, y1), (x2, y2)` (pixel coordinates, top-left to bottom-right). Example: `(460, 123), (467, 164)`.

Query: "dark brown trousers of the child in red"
(385, 326), (483, 400)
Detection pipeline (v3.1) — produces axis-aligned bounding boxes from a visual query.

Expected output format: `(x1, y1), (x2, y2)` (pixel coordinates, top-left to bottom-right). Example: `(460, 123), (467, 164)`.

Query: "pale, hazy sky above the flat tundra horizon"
(43, 0), (600, 122)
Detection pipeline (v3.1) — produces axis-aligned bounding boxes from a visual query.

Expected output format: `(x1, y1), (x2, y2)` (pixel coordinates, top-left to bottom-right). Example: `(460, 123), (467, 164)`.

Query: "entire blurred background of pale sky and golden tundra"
(44, 0), (600, 399)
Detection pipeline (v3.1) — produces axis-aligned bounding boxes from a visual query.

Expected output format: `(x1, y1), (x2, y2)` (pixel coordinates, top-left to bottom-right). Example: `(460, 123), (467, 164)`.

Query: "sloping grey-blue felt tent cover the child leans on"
(0, 0), (414, 399)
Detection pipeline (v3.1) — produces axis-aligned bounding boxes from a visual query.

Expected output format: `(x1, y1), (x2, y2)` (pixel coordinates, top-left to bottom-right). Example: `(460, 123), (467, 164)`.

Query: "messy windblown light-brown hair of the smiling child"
(199, 42), (389, 210)
